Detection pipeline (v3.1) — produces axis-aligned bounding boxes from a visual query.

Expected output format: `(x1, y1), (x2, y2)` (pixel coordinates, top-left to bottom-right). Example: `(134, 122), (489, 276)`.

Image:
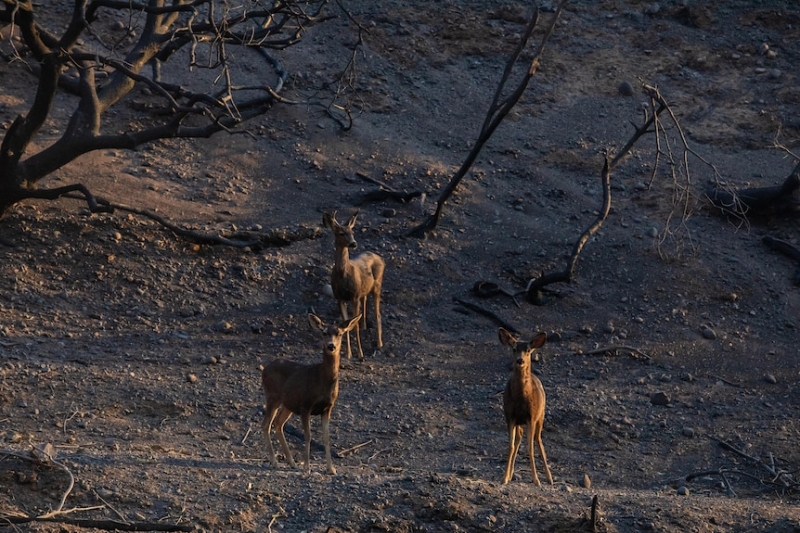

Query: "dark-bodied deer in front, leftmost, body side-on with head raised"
(261, 313), (361, 474)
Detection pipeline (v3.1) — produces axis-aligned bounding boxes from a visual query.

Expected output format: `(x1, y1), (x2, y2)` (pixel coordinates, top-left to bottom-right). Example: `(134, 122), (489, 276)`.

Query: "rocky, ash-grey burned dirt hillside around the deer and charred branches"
(0, 0), (800, 533)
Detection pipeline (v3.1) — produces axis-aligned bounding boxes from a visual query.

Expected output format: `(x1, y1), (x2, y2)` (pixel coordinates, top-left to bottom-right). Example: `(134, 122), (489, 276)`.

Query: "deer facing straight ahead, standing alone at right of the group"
(499, 328), (553, 486)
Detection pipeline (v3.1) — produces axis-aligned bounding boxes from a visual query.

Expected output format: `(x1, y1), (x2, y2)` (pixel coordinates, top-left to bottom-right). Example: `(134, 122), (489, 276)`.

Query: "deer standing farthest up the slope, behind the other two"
(322, 211), (386, 359)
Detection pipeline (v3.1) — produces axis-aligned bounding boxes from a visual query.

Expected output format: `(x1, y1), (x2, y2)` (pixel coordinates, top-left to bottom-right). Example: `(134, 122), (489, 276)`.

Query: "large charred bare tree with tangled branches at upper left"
(0, 0), (338, 220)
